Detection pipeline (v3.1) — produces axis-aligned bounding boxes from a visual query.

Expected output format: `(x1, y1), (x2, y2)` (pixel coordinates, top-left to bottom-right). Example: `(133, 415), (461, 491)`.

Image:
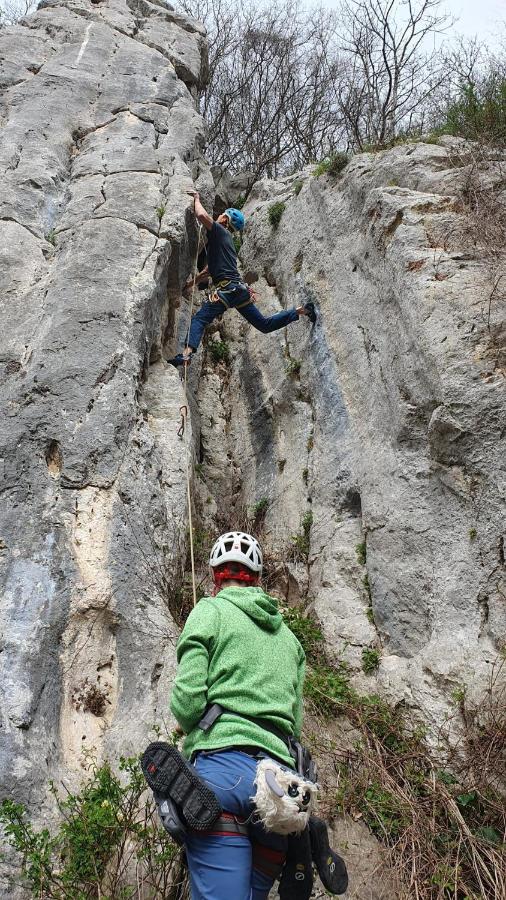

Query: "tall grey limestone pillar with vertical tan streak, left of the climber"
(0, 0), (212, 864)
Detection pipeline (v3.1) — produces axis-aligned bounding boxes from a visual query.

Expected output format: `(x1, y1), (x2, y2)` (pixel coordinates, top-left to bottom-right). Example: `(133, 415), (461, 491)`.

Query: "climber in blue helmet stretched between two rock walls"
(169, 191), (316, 366)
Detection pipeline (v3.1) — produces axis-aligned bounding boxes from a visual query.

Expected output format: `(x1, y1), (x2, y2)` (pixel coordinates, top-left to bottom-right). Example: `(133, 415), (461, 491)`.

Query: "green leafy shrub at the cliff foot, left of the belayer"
(0, 758), (179, 900)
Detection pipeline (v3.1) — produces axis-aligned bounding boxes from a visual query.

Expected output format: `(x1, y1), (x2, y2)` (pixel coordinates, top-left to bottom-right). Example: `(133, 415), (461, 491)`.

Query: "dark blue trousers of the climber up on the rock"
(188, 285), (299, 350)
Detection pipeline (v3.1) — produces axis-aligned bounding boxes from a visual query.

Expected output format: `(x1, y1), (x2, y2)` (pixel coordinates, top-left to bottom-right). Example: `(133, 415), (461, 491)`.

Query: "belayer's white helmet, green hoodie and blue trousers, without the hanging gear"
(170, 532), (305, 900)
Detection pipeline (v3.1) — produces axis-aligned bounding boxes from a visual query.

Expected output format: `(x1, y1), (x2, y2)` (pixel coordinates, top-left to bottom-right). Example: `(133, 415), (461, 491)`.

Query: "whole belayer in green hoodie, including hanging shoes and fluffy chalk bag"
(142, 532), (348, 900)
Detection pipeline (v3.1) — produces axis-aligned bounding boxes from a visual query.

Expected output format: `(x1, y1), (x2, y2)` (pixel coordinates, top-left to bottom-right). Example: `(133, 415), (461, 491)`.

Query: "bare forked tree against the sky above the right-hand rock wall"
(339, 0), (451, 149)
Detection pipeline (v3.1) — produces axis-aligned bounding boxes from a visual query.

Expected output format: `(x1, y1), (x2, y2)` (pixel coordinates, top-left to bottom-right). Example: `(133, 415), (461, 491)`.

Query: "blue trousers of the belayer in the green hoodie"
(186, 750), (286, 900)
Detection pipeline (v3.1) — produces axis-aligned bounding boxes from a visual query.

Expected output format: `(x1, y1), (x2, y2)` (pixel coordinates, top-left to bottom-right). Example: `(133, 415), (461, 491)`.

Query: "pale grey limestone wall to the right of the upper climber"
(195, 140), (506, 729)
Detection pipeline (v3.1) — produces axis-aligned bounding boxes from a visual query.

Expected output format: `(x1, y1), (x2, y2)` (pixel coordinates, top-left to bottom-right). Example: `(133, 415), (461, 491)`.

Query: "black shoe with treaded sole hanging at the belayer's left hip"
(141, 741), (222, 831)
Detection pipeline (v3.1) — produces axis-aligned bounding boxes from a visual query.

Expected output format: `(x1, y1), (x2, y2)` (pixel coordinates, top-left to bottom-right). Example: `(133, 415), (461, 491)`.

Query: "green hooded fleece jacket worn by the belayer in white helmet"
(170, 587), (305, 764)
